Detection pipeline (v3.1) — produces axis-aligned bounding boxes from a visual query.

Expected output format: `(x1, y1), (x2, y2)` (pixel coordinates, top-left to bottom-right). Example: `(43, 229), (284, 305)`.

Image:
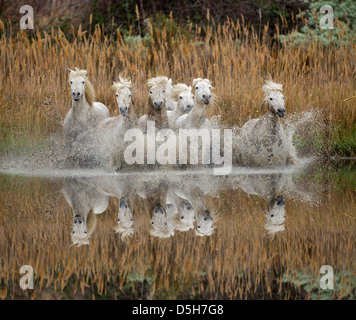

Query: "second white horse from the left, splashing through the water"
(96, 76), (136, 170)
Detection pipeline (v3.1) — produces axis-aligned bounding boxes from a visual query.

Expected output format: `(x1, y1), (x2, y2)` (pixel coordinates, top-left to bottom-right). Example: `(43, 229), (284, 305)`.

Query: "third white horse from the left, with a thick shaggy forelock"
(138, 76), (168, 130)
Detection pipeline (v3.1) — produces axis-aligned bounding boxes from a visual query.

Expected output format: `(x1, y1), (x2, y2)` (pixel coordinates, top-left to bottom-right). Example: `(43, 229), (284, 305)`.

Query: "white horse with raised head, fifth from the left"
(176, 78), (213, 129)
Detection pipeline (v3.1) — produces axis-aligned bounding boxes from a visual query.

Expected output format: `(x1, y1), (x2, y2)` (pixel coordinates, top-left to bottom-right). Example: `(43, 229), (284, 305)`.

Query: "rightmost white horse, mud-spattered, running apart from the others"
(238, 80), (298, 166)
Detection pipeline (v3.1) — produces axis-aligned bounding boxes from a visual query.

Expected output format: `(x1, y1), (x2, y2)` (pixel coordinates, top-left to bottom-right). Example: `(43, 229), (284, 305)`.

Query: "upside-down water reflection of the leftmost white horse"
(62, 178), (109, 247)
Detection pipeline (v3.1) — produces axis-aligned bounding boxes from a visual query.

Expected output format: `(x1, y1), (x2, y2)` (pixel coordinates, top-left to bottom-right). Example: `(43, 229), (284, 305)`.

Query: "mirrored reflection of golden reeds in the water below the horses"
(0, 175), (355, 299)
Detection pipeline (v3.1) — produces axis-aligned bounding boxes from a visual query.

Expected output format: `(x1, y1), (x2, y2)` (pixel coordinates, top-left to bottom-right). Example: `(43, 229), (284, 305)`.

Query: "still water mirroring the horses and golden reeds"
(0, 161), (356, 299)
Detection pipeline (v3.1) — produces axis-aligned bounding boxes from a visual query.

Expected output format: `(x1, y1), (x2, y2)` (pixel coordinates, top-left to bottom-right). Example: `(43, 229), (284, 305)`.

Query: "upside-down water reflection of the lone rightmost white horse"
(241, 174), (286, 235)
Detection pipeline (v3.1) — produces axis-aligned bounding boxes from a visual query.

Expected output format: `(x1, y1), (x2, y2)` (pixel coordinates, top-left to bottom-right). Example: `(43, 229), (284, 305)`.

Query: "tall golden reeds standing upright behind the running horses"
(0, 20), (356, 154)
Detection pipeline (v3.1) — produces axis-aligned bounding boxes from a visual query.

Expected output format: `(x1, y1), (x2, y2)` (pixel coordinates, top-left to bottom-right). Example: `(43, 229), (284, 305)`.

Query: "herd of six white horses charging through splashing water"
(63, 68), (298, 171)
